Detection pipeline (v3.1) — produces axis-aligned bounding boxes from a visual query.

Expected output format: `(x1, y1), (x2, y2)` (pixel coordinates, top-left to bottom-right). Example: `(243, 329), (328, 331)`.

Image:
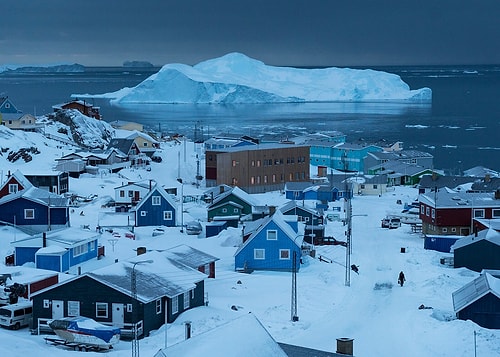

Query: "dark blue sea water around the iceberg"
(0, 66), (500, 174)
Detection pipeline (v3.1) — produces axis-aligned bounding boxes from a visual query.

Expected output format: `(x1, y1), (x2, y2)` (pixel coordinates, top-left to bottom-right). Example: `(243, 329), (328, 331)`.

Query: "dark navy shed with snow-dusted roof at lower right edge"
(452, 272), (500, 329)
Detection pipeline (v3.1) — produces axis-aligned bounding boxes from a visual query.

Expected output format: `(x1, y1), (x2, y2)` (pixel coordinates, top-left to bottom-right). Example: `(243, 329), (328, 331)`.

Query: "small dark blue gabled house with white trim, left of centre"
(131, 185), (177, 227)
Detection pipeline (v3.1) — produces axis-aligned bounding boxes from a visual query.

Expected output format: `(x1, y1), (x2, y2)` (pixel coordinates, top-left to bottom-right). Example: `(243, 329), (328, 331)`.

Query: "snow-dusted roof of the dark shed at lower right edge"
(452, 273), (500, 312)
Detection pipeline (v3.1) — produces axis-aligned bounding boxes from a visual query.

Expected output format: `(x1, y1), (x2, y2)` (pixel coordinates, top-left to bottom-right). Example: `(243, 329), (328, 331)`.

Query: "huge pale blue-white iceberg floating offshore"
(93, 53), (432, 105)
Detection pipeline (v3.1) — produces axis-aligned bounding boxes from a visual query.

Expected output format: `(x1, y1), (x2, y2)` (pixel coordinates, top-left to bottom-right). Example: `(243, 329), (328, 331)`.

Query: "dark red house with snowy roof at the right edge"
(419, 188), (500, 236)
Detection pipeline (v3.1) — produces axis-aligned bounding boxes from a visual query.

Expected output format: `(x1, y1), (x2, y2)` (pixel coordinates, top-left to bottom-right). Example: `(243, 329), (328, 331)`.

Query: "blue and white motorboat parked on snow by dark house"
(48, 316), (120, 349)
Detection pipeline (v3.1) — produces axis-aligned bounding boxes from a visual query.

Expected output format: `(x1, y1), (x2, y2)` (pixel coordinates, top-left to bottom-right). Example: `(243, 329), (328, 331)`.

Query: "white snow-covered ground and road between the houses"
(0, 126), (500, 357)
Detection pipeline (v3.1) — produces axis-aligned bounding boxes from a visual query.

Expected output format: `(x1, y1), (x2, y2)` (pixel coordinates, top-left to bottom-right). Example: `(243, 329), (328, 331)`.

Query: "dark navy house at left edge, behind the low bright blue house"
(0, 186), (69, 234)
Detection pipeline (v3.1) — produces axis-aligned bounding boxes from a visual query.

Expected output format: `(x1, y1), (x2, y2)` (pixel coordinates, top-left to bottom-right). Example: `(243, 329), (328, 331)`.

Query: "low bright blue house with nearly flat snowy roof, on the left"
(11, 227), (100, 272)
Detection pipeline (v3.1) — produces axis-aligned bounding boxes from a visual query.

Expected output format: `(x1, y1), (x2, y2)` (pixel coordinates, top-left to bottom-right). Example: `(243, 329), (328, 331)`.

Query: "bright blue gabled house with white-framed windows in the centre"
(234, 211), (303, 271)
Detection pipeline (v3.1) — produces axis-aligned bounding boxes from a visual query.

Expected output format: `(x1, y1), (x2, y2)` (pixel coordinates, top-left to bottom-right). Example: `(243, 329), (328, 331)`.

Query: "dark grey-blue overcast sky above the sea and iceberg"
(0, 0), (500, 66)
